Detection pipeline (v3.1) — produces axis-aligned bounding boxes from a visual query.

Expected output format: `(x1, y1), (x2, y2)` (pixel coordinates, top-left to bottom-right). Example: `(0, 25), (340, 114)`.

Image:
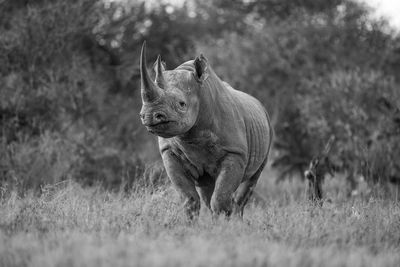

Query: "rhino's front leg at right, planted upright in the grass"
(211, 155), (245, 216)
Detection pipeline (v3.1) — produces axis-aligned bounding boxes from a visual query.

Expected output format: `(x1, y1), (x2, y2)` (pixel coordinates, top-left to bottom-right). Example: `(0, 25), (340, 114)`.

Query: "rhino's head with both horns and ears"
(140, 43), (205, 138)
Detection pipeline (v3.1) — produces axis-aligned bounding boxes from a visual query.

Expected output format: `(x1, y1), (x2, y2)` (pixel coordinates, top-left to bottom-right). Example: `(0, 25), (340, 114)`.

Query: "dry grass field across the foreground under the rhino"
(0, 174), (400, 267)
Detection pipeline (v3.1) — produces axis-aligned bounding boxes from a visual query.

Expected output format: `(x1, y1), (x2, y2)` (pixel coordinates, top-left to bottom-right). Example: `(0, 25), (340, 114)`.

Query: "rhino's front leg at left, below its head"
(162, 151), (200, 220)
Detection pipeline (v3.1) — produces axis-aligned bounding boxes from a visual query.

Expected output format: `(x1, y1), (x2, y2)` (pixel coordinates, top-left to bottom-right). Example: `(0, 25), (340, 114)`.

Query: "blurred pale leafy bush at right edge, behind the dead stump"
(304, 71), (400, 183)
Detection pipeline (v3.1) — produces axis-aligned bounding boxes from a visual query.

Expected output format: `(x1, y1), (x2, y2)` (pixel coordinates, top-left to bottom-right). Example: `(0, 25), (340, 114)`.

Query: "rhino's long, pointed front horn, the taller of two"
(140, 41), (160, 102)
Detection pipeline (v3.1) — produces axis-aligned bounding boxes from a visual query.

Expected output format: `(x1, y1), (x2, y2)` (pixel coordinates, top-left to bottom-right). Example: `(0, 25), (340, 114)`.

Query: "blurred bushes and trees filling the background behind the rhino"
(0, 0), (400, 195)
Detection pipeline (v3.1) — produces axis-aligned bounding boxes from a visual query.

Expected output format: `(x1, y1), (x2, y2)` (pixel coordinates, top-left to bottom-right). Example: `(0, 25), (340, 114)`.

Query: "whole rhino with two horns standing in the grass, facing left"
(140, 42), (272, 219)
